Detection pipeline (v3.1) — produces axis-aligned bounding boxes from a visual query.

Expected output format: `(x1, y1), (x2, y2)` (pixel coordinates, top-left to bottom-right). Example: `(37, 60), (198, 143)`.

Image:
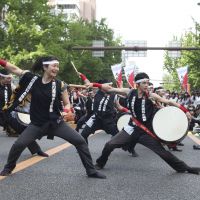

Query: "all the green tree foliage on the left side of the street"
(0, 0), (121, 82)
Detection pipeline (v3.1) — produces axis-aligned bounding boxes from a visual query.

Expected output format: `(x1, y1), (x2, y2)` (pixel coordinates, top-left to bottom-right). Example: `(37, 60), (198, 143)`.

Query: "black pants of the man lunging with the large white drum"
(96, 128), (188, 172)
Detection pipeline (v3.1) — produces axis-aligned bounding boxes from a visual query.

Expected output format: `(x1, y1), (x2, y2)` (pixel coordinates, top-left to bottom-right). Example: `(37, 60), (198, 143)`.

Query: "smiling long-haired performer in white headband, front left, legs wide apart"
(0, 56), (106, 178)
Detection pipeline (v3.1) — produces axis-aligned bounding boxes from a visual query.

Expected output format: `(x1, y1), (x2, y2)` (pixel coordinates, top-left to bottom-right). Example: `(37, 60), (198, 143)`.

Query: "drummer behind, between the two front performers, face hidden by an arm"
(78, 72), (128, 143)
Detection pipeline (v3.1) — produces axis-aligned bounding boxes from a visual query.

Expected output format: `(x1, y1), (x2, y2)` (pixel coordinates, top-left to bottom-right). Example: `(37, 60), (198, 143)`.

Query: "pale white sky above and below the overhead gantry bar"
(96, 0), (200, 85)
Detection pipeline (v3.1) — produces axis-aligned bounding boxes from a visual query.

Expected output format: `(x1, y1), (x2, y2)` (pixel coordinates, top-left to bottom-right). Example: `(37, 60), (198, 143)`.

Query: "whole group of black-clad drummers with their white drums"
(0, 56), (200, 178)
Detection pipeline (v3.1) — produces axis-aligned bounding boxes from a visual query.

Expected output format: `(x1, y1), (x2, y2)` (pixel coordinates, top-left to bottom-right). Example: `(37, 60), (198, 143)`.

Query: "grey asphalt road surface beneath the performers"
(0, 126), (200, 200)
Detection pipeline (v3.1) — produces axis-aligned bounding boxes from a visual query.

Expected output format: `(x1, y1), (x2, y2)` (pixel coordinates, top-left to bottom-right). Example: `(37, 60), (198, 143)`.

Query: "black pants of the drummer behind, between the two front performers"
(81, 115), (119, 143)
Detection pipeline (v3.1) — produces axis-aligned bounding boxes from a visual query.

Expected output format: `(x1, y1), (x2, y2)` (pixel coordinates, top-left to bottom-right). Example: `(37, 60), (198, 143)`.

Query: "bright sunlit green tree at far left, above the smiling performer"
(0, 0), (67, 68)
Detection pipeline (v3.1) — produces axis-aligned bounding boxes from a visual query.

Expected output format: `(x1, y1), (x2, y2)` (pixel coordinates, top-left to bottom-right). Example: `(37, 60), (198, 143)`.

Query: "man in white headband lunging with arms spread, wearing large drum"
(87, 73), (200, 174)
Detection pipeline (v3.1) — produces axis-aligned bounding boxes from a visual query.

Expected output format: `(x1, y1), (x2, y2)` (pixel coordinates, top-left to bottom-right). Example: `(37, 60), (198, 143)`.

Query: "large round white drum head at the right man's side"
(152, 106), (189, 143)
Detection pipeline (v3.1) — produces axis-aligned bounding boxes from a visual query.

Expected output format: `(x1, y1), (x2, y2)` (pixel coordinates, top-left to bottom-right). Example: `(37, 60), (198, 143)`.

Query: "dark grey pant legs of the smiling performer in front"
(4, 122), (96, 174)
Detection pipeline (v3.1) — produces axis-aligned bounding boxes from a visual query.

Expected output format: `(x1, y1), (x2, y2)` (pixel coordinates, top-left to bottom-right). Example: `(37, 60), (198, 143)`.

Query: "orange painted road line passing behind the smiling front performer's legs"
(0, 130), (101, 181)
